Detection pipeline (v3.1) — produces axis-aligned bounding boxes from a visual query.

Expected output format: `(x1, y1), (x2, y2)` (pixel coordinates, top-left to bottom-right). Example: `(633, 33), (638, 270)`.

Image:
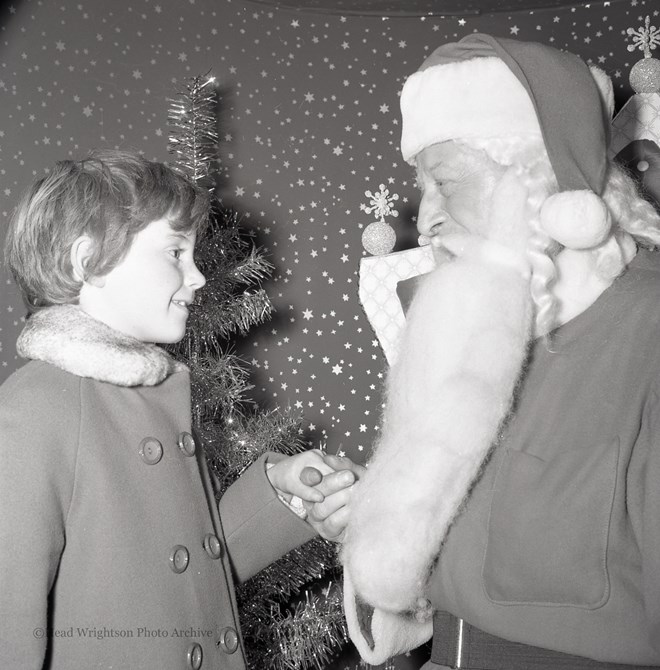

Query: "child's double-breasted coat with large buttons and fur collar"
(0, 306), (313, 670)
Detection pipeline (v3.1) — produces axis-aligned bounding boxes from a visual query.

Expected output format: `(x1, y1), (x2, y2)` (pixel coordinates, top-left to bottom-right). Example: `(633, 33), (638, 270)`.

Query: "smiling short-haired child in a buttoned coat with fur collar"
(0, 151), (354, 670)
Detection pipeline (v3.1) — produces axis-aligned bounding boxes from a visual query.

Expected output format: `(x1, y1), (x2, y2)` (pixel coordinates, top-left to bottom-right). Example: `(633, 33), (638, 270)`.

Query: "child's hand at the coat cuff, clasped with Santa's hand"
(266, 449), (334, 503)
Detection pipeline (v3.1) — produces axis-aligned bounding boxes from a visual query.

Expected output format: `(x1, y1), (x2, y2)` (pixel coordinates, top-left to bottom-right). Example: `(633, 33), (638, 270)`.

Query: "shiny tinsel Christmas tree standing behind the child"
(168, 76), (347, 670)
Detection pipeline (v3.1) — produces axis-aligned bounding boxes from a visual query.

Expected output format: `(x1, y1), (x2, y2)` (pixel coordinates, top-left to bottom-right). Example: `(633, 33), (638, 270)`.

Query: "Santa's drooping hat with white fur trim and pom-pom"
(401, 34), (614, 249)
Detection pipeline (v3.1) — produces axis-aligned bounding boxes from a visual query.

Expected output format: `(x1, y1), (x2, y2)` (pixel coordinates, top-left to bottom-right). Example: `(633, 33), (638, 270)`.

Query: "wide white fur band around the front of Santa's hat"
(401, 57), (541, 165)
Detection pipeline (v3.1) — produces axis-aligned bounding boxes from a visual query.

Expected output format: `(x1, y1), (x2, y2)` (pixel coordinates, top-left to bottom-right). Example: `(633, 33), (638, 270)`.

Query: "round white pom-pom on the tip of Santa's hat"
(541, 191), (612, 249)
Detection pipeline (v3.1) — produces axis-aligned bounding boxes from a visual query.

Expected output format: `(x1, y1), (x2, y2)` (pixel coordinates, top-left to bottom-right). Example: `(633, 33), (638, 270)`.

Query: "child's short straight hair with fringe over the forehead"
(5, 150), (209, 311)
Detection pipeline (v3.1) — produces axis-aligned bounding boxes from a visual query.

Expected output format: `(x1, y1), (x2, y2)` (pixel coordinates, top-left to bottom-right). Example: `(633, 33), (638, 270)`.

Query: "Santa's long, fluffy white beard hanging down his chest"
(342, 247), (532, 612)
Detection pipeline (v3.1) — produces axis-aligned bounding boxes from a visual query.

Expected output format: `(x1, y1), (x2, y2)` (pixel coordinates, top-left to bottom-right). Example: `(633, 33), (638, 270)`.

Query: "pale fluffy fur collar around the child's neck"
(16, 305), (187, 386)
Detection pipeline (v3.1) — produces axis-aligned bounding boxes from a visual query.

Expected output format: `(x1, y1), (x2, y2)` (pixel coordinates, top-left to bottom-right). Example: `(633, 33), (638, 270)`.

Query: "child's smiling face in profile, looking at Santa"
(80, 218), (206, 343)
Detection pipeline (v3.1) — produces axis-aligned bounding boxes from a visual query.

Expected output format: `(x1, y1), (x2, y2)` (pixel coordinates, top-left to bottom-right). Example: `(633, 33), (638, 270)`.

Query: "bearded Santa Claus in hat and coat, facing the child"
(342, 34), (660, 670)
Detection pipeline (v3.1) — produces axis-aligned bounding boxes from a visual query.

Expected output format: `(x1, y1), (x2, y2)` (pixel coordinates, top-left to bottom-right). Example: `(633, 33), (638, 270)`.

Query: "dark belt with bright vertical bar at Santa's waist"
(431, 612), (660, 670)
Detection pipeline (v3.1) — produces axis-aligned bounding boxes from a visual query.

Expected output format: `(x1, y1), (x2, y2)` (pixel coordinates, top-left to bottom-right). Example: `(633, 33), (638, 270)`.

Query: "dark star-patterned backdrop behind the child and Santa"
(0, 0), (659, 670)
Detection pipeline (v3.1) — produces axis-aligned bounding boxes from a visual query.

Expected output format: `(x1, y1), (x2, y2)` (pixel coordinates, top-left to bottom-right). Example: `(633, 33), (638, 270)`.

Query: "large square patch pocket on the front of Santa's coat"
(482, 439), (619, 609)
